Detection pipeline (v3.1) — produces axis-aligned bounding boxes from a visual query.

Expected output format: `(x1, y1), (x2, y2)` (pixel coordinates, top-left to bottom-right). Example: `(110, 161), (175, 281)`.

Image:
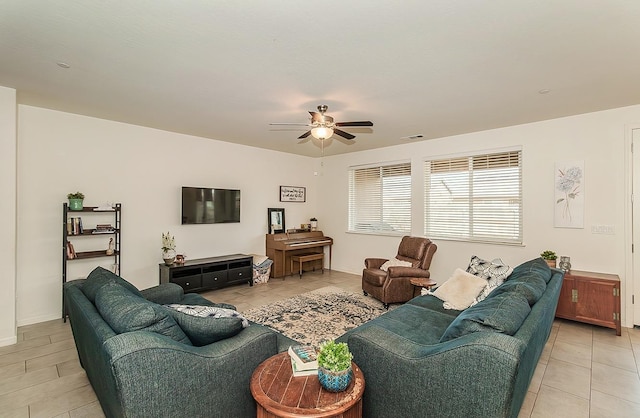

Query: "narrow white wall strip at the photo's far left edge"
(0, 87), (16, 347)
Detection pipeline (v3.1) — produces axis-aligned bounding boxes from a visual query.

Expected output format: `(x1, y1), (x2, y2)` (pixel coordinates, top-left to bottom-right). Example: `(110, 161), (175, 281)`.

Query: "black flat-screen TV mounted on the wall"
(182, 187), (240, 225)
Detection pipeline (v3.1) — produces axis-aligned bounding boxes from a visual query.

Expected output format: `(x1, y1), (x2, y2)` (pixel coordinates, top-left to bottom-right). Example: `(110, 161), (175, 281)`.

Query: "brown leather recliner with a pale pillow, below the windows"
(362, 236), (438, 308)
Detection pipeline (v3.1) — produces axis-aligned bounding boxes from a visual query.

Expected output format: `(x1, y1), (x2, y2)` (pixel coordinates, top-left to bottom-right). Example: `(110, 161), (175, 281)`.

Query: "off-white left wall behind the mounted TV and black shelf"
(18, 105), (318, 325)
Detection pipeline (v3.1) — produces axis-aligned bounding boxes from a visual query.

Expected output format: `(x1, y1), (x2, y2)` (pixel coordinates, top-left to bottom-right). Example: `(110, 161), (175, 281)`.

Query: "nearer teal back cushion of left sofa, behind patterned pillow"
(95, 282), (192, 345)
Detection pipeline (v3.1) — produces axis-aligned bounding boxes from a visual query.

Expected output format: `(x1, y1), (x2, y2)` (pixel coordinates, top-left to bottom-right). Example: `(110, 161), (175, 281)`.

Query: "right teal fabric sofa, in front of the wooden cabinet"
(338, 258), (563, 418)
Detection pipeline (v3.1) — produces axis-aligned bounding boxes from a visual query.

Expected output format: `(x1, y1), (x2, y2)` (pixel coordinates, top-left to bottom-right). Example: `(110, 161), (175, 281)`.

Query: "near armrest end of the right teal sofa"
(338, 325), (525, 417)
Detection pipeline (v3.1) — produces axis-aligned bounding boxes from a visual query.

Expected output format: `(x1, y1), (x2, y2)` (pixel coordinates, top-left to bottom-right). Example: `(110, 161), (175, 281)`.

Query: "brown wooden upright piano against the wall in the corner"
(265, 231), (333, 277)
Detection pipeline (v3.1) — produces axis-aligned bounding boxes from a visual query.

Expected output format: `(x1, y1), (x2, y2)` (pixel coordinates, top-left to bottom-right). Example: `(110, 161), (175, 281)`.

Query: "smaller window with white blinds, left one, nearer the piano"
(349, 162), (411, 235)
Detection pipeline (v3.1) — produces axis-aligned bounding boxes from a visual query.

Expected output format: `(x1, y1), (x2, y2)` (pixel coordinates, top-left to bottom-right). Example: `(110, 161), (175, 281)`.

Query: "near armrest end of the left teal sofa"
(104, 326), (277, 417)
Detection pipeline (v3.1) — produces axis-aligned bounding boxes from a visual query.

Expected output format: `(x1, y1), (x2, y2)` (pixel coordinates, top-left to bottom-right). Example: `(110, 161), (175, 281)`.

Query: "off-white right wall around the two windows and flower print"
(318, 106), (640, 326)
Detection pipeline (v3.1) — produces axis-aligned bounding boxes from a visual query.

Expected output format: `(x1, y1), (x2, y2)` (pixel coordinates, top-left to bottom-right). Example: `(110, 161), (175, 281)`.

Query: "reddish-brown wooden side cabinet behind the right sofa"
(556, 270), (622, 335)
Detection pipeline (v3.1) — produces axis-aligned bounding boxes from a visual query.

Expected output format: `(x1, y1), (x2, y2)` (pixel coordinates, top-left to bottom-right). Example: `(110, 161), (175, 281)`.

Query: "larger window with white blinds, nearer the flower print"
(424, 150), (522, 244)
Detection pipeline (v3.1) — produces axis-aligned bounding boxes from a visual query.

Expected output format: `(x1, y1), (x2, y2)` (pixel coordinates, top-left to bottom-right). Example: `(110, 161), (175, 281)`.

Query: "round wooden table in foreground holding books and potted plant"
(251, 352), (364, 418)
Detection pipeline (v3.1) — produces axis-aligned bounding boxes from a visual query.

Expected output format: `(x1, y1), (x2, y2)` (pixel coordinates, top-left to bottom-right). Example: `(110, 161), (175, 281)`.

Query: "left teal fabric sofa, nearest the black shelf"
(64, 268), (295, 418)
